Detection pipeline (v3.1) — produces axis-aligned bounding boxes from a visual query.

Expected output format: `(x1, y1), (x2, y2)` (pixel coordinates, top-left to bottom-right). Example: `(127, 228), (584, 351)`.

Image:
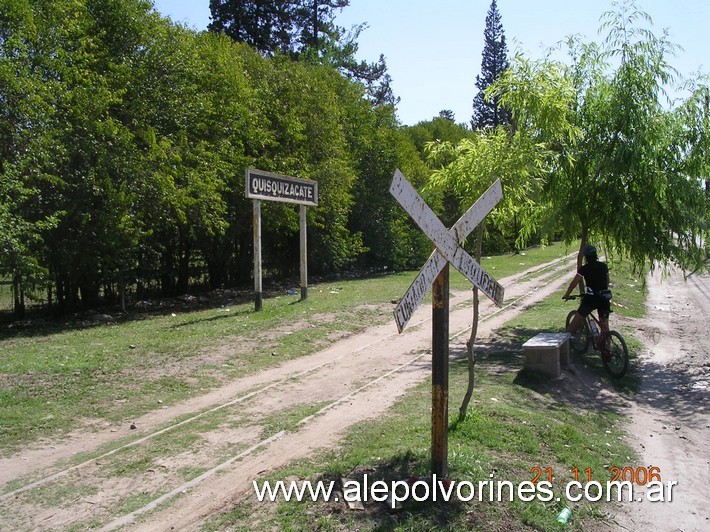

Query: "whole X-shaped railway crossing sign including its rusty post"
(390, 170), (504, 479)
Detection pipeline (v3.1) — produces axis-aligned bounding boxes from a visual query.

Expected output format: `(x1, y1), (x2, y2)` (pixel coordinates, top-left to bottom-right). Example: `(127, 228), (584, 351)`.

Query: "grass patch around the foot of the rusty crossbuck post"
(209, 360), (634, 530)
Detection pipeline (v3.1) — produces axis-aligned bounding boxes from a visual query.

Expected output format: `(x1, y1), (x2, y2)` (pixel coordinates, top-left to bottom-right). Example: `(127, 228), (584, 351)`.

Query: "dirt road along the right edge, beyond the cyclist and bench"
(617, 272), (710, 532)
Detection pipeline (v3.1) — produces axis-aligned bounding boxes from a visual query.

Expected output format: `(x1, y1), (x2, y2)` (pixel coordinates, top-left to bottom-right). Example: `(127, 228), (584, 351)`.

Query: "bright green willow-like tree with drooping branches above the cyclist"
(495, 2), (708, 267)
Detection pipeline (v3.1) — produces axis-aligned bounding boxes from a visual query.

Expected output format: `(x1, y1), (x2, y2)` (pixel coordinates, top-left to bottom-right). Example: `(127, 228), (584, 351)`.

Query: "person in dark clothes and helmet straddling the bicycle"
(562, 244), (611, 340)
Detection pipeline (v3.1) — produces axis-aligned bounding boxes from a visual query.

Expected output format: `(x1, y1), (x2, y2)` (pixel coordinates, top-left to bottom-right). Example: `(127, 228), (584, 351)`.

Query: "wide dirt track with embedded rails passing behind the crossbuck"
(0, 254), (572, 530)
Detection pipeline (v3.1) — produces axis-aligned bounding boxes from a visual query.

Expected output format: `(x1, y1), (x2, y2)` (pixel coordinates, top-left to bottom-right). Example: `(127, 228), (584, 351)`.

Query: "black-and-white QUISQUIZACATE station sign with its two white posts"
(244, 168), (318, 311)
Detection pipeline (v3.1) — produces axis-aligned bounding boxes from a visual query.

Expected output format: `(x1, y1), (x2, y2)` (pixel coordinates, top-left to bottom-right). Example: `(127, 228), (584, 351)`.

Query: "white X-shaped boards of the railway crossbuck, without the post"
(390, 170), (505, 332)
